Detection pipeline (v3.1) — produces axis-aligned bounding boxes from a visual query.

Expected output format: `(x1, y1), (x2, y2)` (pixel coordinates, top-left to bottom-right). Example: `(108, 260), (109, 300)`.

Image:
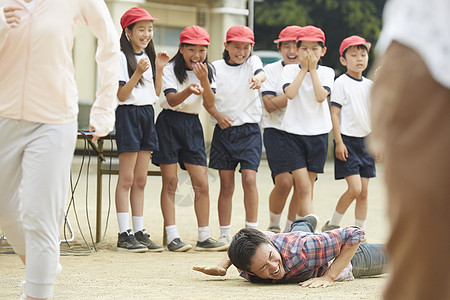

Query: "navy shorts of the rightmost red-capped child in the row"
(334, 135), (376, 179)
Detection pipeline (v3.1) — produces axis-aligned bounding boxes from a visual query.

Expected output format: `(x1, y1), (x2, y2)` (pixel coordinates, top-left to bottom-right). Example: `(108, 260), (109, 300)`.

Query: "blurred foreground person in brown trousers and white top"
(371, 0), (450, 300)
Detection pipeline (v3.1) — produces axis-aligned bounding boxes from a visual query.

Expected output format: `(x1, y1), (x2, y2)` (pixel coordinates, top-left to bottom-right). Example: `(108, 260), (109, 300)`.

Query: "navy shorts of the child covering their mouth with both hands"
(286, 133), (328, 173)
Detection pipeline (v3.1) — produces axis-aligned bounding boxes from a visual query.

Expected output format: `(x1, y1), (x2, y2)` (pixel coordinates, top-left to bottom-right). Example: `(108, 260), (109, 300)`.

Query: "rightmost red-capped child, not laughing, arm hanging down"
(322, 35), (376, 237)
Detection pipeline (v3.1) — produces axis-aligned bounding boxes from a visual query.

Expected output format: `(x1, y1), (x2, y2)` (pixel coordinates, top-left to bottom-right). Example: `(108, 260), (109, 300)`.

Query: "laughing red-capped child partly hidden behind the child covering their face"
(261, 26), (301, 233)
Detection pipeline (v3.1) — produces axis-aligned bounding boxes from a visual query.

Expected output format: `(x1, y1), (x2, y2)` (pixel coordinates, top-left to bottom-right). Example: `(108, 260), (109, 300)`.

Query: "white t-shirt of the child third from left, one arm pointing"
(211, 55), (263, 126)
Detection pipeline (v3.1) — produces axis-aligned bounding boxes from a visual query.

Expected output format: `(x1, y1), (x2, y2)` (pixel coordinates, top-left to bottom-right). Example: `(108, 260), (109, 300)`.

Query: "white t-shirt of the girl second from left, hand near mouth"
(161, 62), (216, 114)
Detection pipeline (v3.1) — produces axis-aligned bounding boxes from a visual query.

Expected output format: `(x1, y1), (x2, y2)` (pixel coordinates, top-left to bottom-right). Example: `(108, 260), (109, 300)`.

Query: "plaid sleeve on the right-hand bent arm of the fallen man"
(301, 226), (365, 269)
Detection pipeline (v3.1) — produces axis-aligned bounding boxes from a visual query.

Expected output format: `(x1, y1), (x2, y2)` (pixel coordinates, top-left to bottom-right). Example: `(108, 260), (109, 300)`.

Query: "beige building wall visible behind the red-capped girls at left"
(73, 0), (248, 143)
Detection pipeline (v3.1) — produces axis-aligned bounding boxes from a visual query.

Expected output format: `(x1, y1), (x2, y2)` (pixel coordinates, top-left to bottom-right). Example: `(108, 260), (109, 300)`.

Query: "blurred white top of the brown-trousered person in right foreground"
(377, 0), (450, 88)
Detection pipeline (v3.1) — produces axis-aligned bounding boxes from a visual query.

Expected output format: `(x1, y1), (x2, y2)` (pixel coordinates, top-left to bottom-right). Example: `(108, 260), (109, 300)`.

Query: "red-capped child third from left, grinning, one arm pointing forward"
(208, 25), (266, 244)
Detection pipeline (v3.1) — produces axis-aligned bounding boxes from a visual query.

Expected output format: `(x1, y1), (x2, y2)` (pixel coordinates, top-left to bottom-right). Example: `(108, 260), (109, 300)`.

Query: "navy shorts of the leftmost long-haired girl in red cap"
(116, 105), (159, 154)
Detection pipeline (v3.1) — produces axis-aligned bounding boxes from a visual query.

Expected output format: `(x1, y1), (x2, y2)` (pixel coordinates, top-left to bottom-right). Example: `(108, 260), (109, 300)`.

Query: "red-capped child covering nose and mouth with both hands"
(282, 26), (334, 216)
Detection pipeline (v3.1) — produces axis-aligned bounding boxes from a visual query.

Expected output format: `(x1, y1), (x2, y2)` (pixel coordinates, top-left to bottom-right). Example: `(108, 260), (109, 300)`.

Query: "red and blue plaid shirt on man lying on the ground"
(239, 226), (365, 283)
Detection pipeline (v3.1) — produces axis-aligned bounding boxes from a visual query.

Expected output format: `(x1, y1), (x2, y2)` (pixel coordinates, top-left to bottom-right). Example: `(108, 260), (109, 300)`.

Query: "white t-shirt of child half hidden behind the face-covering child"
(261, 60), (286, 130)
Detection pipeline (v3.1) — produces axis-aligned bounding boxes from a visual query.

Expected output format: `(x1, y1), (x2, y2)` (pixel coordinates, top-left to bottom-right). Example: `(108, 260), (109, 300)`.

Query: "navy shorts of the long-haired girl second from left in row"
(152, 109), (206, 170)
